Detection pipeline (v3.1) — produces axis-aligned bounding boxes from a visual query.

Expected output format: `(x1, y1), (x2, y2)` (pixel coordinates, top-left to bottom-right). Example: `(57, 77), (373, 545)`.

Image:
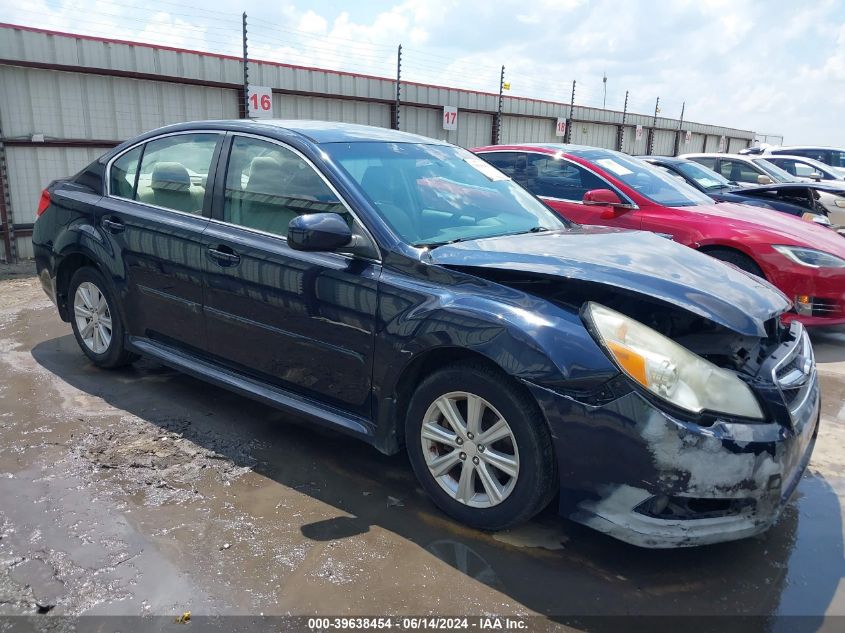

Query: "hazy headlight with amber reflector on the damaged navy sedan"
(585, 302), (764, 419)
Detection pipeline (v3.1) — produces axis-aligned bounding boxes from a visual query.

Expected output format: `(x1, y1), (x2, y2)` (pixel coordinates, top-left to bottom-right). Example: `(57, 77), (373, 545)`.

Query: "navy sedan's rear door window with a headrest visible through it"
(134, 134), (219, 214)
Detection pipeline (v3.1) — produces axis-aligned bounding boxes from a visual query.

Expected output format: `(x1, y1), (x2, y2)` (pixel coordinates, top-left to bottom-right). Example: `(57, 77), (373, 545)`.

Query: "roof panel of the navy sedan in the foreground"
(132, 119), (448, 145)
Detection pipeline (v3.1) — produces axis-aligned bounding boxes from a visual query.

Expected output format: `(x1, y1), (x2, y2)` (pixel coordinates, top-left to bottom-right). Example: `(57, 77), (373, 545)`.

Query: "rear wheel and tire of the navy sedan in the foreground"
(68, 266), (138, 369)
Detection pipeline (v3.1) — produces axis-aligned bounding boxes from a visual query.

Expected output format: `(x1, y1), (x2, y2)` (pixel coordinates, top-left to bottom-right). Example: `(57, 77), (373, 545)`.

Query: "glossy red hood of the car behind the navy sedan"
(684, 202), (845, 257)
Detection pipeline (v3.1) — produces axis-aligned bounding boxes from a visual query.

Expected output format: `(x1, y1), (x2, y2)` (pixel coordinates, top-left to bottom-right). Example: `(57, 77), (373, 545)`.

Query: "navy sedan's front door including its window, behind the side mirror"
(204, 135), (381, 414)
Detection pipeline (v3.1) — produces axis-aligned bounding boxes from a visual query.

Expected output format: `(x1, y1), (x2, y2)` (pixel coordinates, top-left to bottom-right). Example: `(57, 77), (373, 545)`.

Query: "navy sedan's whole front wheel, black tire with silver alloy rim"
(405, 363), (557, 530)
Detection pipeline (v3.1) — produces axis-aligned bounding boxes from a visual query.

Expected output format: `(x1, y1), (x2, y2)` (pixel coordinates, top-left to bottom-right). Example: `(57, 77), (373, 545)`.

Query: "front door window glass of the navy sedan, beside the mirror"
(223, 136), (351, 236)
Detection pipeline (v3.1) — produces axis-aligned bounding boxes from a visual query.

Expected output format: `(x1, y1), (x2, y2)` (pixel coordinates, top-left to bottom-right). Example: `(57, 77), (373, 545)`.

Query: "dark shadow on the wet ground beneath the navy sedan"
(32, 335), (845, 631)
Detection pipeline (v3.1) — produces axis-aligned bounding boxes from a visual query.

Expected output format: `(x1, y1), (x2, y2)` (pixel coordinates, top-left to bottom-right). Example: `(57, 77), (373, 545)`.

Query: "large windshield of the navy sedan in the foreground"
(321, 142), (569, 246)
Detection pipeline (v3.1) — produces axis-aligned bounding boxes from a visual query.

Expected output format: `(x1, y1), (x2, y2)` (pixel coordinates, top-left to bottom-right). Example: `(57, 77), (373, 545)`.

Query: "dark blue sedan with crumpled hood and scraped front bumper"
(33, 121), (819, 547)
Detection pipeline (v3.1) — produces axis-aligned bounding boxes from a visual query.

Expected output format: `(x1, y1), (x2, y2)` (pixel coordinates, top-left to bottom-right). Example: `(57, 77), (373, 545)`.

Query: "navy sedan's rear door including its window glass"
(98, 131), (223, 349)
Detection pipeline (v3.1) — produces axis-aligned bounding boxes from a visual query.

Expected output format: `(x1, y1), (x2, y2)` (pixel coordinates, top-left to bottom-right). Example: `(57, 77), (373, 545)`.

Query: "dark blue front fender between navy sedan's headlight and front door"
(373, 267), (619, 452)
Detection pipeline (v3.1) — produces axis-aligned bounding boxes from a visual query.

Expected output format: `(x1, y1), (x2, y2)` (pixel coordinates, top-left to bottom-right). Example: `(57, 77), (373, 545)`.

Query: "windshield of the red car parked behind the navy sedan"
(572, 149), (713, 207)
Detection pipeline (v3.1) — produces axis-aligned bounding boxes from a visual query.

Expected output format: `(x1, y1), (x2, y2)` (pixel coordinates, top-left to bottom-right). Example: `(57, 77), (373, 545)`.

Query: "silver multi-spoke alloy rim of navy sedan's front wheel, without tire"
(420, 391), (519, 508)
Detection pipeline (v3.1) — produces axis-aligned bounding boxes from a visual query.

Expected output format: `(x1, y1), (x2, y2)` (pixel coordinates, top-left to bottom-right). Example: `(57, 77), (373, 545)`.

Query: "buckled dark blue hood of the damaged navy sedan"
(429, 227), (792, 336)
